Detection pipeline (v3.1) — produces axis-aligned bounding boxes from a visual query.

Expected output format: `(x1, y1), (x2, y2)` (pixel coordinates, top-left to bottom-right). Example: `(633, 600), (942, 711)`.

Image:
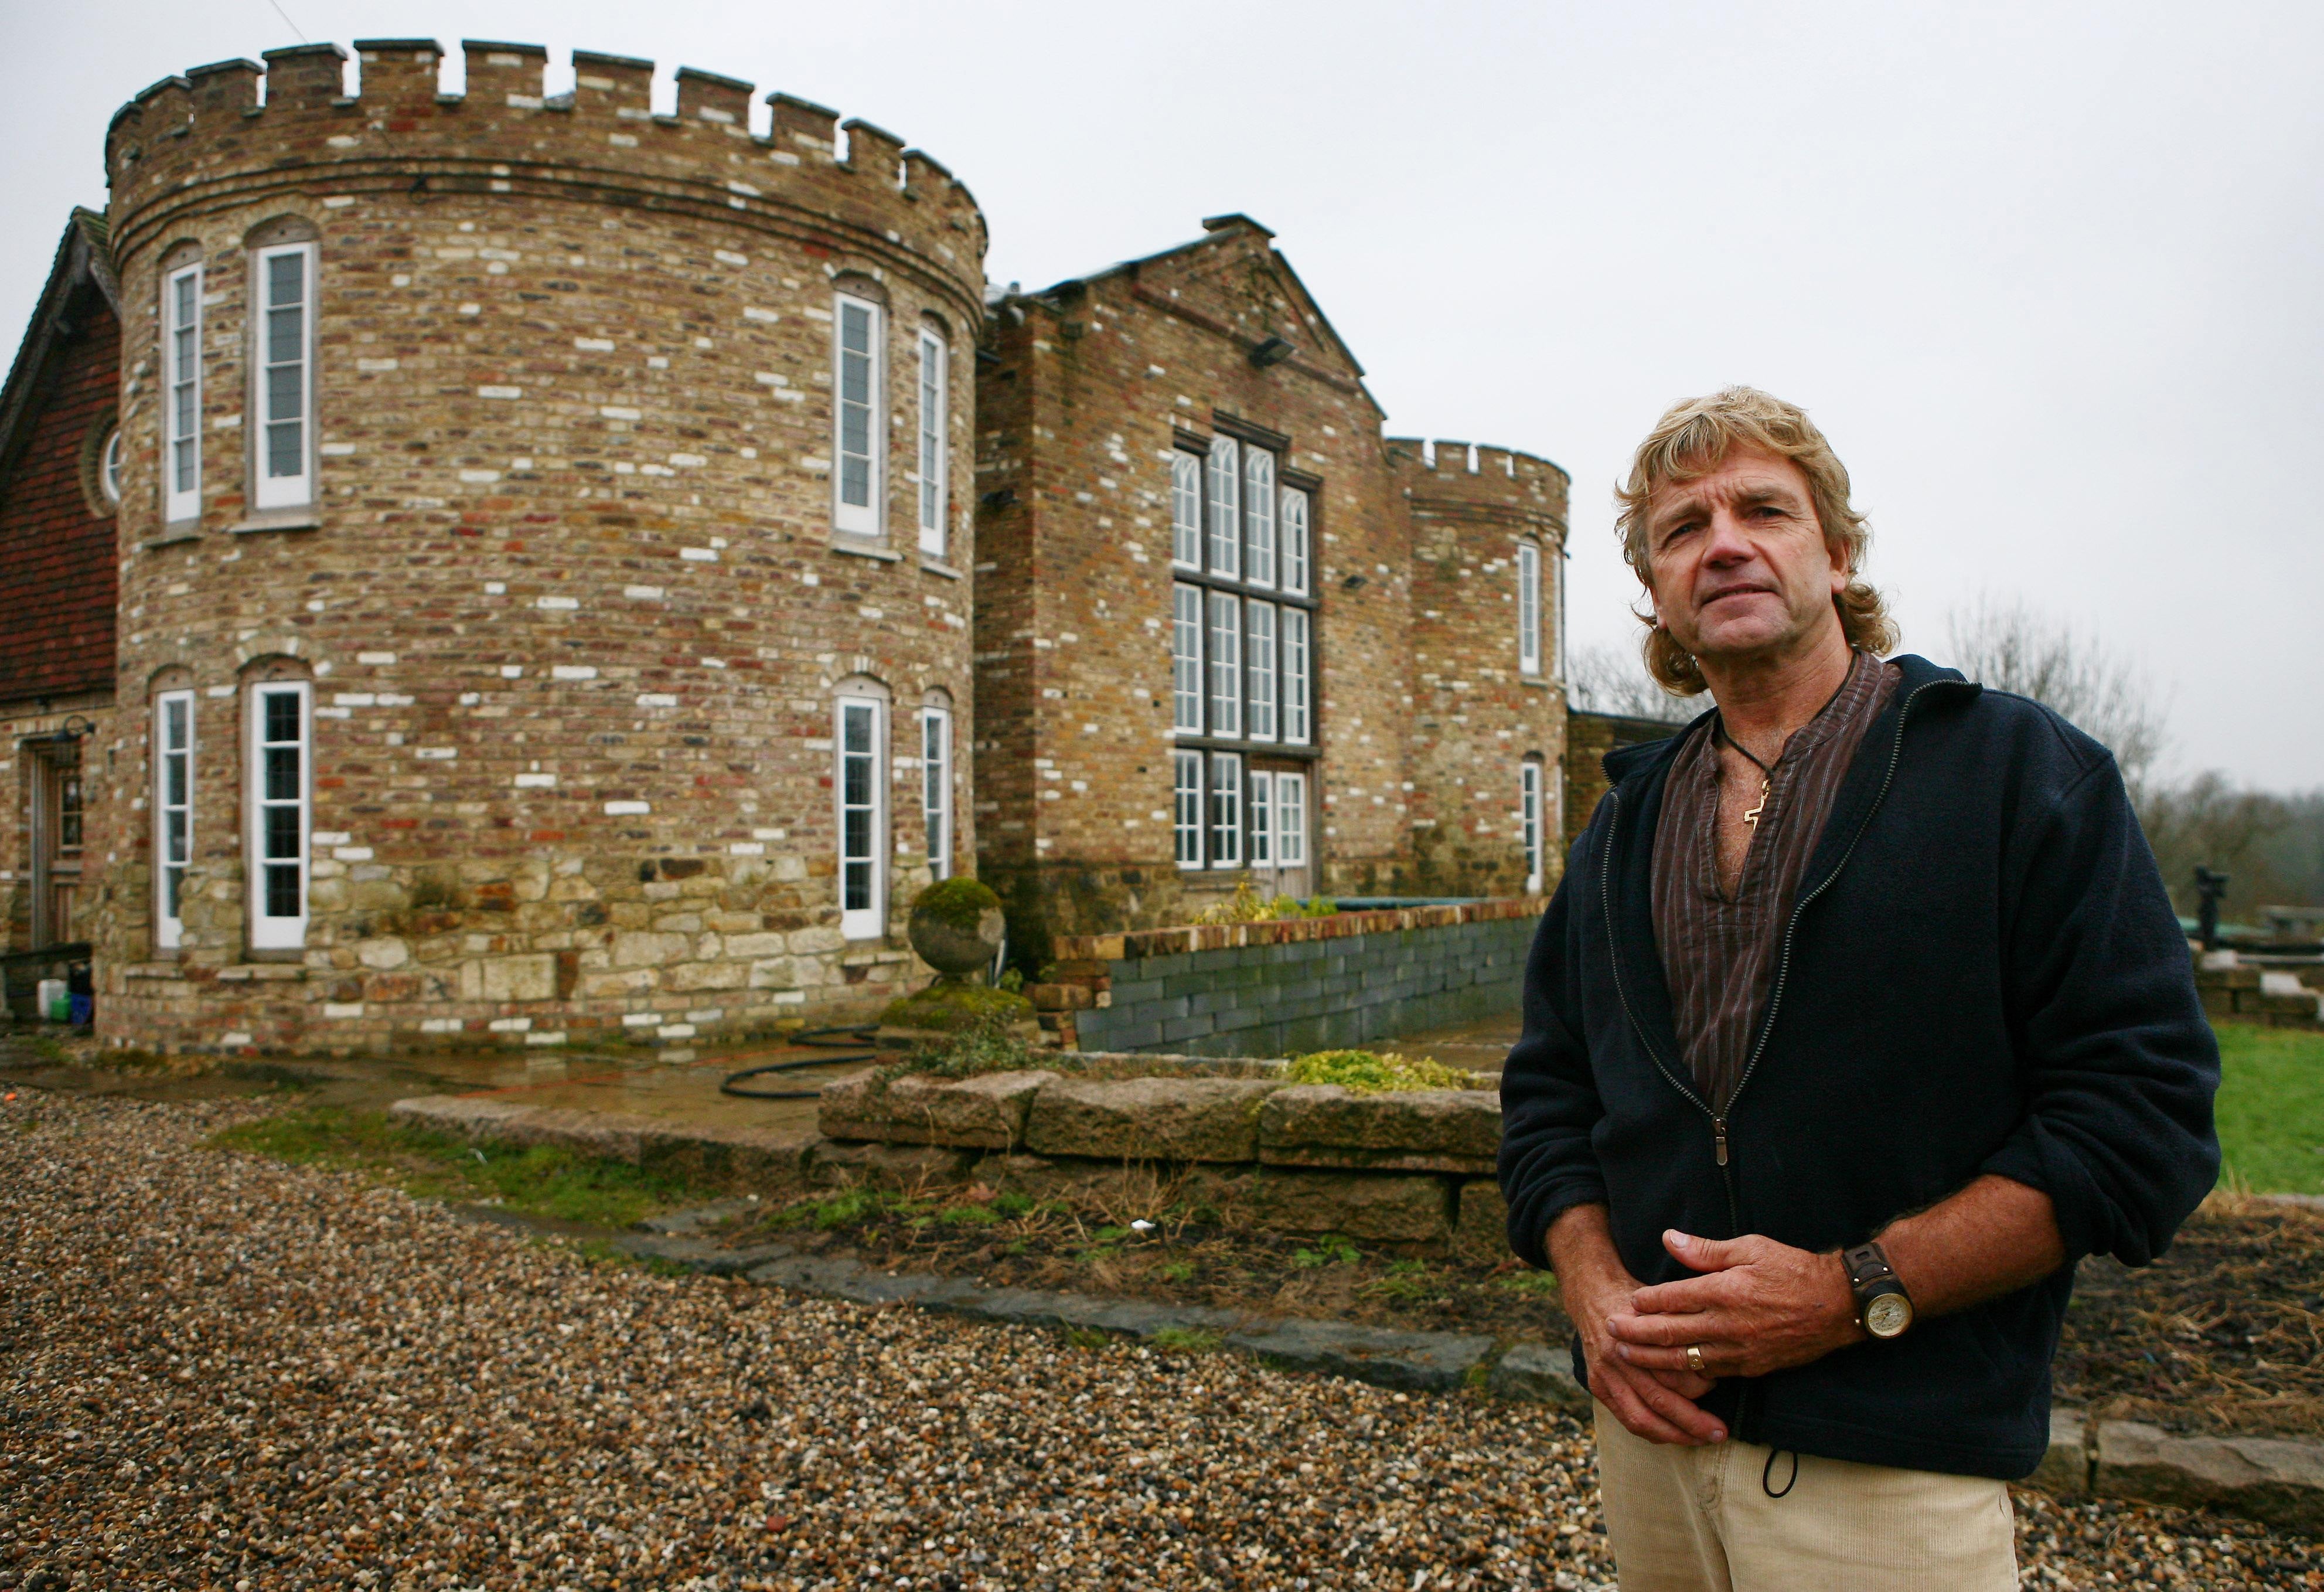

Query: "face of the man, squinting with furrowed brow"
(1645, 448), (1848, 660)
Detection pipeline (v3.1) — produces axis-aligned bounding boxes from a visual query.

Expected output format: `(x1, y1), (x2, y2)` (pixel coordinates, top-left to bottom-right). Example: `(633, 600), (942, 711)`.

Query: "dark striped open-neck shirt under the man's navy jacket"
(1655, 651), (1903, 1113)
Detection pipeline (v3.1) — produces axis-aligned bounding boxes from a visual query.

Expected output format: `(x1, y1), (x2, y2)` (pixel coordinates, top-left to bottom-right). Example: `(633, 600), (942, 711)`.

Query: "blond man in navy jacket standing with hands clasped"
(1501, 388), (2220, 1592)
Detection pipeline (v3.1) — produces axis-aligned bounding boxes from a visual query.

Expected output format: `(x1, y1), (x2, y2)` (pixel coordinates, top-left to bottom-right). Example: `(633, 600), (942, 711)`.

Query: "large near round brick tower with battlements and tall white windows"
(88, 39), (986, 1050)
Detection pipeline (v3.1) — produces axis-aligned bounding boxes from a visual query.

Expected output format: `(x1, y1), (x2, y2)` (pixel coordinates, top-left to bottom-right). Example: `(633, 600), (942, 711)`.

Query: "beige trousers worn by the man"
(1597, 1404), (2017, 1592)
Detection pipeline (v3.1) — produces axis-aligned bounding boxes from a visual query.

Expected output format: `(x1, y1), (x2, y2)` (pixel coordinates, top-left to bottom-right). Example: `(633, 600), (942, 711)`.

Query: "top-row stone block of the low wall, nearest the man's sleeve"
(1260, 1083), (1501, 1176)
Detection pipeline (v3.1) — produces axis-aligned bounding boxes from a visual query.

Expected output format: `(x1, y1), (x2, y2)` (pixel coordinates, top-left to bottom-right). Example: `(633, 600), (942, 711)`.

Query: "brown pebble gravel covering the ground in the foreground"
(0, 1093), (2324, 1592)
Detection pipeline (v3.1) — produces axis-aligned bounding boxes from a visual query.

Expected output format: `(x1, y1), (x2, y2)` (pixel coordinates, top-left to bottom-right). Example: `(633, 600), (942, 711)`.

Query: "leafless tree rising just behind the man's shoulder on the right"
(1945, 597), (2170, 802)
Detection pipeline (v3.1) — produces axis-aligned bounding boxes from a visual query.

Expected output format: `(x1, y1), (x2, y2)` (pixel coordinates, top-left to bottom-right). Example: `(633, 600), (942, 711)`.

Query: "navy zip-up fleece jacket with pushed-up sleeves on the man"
(1501, 658), (2220, 1478)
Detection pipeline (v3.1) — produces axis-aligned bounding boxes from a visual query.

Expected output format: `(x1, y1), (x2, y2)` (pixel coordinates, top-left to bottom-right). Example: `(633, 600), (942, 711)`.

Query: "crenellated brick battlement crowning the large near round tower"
(104, 39), (986, 302)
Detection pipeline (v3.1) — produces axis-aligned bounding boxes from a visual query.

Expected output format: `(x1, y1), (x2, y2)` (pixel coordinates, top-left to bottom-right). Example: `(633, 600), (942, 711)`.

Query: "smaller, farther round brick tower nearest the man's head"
(1388, 437), (1569, 895)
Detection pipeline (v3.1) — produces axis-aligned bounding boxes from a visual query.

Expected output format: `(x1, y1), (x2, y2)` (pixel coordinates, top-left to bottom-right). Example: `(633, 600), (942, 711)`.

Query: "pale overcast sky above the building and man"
(0, 0), (2324, 788)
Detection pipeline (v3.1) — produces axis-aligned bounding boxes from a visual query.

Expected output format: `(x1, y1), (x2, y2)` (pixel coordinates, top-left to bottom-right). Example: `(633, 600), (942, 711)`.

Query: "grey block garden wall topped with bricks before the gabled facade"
(1027, 897), (1543, 1055)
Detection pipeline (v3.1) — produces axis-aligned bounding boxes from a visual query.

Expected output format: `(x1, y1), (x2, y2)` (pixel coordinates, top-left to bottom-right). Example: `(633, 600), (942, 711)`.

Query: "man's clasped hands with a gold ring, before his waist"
(1566, 1229), (1864, 1443)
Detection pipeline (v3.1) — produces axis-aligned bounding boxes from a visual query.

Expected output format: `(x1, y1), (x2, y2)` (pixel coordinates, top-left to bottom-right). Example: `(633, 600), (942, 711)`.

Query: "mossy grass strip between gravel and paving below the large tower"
(209, 1106), (714, 1227)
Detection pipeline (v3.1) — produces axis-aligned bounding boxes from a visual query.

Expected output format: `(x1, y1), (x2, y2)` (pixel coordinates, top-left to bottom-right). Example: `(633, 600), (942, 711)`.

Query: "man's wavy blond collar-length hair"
(1615, 386), (1896, 697)
